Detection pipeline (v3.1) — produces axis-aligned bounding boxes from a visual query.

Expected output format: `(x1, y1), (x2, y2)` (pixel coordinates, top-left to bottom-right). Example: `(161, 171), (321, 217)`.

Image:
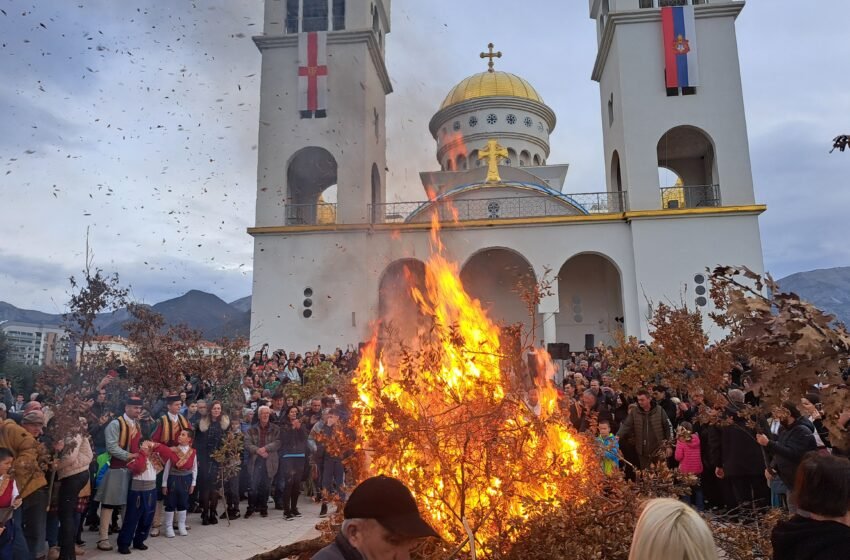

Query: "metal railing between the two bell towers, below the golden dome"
(369, 191), (626, 223)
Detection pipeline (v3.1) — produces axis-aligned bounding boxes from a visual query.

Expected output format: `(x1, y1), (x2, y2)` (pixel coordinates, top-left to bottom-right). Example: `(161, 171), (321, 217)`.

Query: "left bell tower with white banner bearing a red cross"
(254, 0), (392, 227)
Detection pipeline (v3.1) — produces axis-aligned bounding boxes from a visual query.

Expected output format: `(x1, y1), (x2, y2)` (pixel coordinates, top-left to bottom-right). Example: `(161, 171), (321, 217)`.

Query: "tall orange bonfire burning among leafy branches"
(353, 220), (601, 557)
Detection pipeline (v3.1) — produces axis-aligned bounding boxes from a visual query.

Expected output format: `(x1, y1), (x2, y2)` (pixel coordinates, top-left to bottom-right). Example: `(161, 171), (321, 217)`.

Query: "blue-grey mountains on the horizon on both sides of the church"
(0, 266), (850, 340)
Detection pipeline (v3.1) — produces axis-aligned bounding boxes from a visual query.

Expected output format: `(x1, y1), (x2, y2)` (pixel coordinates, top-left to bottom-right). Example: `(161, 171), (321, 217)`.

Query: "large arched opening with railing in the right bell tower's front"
(657, 126), (720, 208)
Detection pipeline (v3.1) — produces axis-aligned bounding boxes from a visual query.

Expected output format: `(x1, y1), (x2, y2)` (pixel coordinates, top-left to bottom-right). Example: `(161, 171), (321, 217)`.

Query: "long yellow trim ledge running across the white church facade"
(248, 204), (767, 235)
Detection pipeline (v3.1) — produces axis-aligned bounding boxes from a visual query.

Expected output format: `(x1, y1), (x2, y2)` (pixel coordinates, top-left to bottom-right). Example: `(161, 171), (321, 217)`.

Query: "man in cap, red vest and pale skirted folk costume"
(95, 396), (142, 550)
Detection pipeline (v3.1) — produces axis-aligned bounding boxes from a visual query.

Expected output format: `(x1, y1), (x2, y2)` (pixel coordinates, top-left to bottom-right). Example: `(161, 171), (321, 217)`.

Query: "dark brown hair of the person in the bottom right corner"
(793, 453), (850, 517)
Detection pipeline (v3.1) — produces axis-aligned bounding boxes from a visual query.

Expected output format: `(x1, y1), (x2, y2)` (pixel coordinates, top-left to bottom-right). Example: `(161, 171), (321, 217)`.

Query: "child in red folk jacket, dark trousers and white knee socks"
(154, 430), (198, 538)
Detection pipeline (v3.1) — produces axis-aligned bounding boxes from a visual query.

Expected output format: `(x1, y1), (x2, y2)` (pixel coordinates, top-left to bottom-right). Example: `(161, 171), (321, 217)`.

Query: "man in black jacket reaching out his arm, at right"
(756, 402), (817, 513)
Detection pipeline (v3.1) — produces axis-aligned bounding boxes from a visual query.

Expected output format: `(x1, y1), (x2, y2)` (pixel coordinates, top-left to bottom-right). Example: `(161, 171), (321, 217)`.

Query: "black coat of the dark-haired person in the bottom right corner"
(770, 515), (850, 560)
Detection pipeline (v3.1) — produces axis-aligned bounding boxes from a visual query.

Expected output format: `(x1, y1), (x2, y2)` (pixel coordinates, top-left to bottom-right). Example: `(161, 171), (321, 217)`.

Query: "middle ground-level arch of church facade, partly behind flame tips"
(460, 248), (542, 343)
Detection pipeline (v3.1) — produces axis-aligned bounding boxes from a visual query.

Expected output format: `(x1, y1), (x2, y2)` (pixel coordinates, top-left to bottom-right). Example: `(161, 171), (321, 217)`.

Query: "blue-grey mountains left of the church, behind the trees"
(0, 290), (251, 341)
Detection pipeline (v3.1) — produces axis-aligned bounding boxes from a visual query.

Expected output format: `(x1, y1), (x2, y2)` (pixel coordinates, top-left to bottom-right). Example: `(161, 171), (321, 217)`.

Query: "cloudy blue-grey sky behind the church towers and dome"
(0, 0), (850, 312)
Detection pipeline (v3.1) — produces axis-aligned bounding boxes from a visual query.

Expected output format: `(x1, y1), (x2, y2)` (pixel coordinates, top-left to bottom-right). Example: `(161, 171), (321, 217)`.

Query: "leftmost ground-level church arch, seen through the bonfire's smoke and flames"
(378, 259), (428, 343)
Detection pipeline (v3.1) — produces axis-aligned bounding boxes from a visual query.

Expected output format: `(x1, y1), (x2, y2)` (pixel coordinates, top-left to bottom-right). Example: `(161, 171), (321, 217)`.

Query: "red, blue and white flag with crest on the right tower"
(661, 6), (699, 88)
